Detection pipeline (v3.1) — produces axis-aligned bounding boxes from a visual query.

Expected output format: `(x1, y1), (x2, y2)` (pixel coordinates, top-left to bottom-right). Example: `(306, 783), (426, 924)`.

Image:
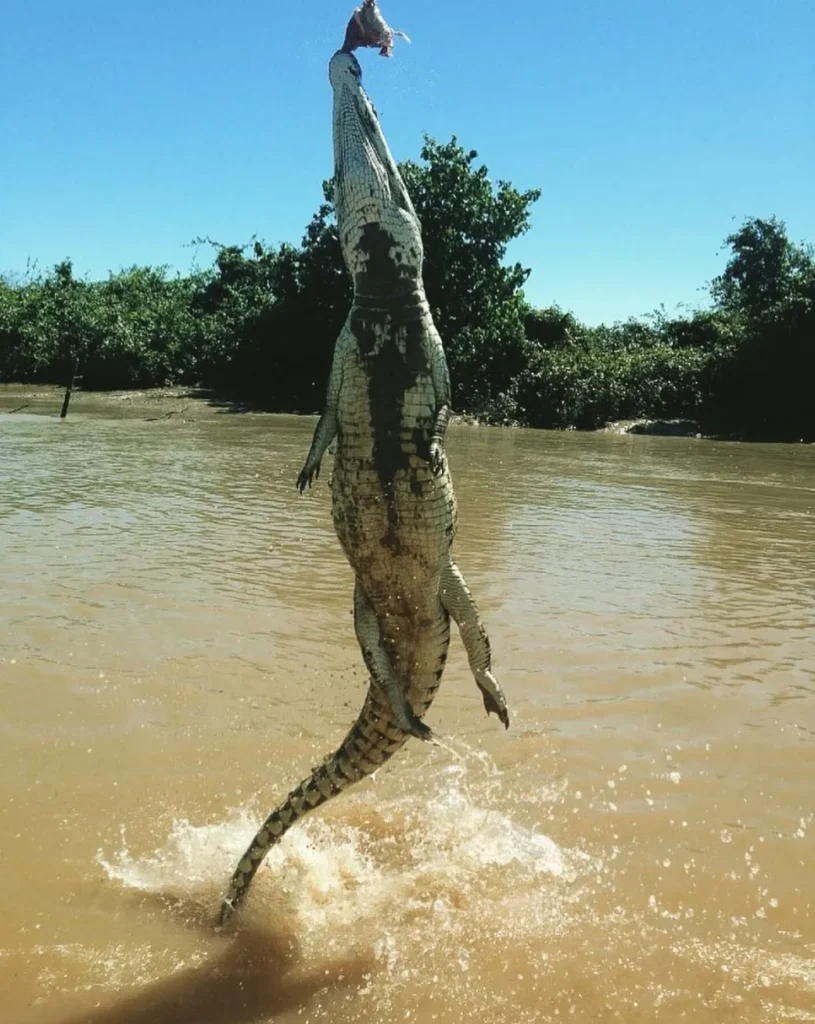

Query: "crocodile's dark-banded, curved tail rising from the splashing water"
(220, 686), (408, 925)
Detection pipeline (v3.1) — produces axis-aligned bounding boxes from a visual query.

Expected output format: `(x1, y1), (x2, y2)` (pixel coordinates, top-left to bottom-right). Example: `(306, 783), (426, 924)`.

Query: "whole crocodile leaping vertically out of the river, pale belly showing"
(221, 12), (509, 923)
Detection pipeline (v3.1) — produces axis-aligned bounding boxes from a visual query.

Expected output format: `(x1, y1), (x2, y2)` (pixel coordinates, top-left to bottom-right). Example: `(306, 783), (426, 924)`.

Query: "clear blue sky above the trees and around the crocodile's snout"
(0, 0), (815, 323)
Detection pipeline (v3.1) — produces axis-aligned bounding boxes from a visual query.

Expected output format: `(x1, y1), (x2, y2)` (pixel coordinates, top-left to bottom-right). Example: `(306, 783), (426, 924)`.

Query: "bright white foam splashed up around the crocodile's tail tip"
(97, 765), (577, 933)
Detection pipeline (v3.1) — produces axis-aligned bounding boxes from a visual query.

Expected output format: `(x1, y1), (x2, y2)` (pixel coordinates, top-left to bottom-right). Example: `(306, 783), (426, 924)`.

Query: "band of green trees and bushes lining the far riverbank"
(0, 138), (815, 440)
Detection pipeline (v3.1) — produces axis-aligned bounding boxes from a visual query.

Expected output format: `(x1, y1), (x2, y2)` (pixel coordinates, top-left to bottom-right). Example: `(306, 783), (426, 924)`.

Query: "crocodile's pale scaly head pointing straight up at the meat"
(329, 50), (423, 294)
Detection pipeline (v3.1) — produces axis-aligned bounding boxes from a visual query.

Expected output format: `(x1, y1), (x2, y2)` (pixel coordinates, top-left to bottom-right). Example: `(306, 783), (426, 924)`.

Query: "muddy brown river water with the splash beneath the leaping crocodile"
(0, 387), (815, 1024)
